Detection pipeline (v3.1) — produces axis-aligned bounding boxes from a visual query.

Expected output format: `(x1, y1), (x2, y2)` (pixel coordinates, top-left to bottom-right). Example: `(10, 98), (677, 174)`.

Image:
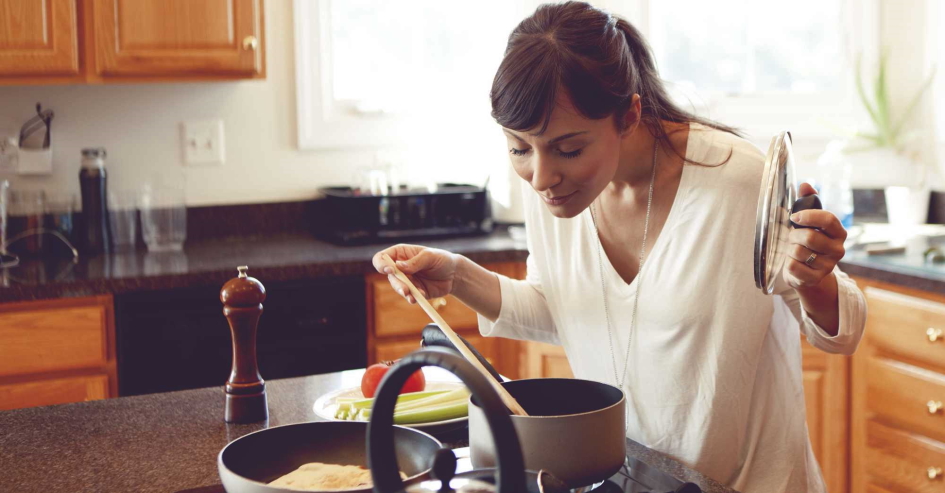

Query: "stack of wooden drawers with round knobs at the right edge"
(852, 283), (945, 493)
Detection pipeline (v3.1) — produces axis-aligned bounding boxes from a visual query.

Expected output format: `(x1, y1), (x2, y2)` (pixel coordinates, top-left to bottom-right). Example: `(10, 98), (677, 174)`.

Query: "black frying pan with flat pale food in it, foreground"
(217, 421), (441, 493)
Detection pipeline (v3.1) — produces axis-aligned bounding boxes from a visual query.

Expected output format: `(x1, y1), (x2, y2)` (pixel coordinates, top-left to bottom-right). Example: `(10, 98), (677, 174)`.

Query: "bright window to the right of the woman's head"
(608, 0), (879, 146)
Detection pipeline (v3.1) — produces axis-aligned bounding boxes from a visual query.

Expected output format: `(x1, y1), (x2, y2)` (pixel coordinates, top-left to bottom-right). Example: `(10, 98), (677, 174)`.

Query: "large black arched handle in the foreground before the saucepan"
(367, 348), (527, 493)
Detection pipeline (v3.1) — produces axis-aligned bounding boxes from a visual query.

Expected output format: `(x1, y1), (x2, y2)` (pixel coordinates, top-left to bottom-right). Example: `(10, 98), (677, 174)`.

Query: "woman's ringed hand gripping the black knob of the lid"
(784, 183), (847, 291)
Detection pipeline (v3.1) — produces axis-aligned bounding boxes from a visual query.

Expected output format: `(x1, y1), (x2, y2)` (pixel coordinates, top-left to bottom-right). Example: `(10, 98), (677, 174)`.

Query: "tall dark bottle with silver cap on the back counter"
(79, 147), (111, 254)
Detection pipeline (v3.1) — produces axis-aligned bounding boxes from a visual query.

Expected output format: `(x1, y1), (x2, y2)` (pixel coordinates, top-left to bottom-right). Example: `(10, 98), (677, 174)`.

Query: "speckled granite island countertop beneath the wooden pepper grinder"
(0, 370), (732, 493)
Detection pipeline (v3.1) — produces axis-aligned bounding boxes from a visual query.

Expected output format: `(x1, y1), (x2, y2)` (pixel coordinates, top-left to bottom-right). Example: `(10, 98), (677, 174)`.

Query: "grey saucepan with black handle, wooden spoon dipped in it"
(423, 330), (627, 488)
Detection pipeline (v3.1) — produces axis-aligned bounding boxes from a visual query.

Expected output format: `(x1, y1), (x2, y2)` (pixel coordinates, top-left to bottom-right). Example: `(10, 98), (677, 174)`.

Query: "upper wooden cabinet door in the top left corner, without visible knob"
(0, 0), (79, 77)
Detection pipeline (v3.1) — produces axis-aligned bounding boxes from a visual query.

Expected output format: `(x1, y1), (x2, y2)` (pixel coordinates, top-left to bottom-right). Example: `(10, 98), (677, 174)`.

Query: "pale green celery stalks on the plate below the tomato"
(335, 387), (469, 425)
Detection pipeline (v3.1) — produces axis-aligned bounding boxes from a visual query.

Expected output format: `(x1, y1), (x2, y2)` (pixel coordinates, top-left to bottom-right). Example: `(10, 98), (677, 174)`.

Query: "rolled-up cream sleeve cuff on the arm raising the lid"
(780, 268), (866, 355)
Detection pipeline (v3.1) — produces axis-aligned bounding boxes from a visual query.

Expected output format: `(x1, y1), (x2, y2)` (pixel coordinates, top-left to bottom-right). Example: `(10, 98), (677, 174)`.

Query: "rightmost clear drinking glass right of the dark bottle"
(138, 185), (187, 252)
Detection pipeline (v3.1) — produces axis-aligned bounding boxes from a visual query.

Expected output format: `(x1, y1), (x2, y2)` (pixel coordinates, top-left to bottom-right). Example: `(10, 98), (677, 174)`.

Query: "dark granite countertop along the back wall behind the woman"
(0, 227), (945, 303)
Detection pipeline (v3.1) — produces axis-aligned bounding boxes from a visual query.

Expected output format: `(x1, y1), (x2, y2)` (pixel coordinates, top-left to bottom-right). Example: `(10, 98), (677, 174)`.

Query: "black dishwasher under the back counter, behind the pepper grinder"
(115, 276), (367, 396)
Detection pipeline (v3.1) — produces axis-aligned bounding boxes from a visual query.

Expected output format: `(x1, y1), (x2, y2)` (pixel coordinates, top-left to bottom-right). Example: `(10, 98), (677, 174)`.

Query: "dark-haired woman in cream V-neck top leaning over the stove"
(374, 2), (866, 493)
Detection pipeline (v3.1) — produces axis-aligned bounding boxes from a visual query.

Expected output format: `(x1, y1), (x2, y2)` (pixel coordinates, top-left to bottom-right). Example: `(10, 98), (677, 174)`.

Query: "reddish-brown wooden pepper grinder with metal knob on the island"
(220, 266), (269, 423)
